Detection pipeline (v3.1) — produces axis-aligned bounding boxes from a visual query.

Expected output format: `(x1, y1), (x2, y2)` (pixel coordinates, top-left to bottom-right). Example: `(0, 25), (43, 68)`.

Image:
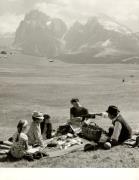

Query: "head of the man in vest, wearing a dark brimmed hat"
(106, 105), (120, 119)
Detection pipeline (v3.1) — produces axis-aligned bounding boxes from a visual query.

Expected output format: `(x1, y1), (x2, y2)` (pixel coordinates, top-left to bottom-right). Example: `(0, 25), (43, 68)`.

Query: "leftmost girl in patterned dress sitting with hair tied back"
(9, 120), (28, 159)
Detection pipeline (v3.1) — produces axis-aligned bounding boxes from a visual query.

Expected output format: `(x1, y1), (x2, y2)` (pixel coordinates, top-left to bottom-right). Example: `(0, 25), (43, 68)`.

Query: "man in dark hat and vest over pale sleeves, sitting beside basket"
(97, 105), (132, 147)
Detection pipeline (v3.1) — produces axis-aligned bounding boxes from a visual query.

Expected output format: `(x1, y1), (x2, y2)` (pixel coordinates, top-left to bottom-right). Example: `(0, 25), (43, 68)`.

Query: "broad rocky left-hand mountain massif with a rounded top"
(15, 10), (67, 57)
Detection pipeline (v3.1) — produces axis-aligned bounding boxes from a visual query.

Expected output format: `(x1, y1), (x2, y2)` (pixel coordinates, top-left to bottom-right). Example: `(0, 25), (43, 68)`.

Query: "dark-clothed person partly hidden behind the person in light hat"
(40, 114), (52, 139)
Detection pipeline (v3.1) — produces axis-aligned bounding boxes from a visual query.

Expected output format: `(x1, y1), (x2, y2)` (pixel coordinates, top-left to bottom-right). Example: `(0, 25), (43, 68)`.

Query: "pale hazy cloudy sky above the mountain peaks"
(0, 0), (139, 33)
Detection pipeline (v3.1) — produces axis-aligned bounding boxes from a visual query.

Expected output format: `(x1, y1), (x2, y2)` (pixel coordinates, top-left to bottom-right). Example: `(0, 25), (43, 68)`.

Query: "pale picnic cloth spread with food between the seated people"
(0, 133), (90, 157)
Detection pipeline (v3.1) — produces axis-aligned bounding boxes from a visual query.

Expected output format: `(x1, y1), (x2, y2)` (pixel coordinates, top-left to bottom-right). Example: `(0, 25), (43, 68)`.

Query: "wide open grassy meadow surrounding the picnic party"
(0, 54), (139, 167)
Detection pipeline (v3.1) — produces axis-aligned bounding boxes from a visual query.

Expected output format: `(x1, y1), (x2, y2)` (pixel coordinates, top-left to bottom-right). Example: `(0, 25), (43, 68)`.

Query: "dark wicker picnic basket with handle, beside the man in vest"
(82, 123), (102, 142)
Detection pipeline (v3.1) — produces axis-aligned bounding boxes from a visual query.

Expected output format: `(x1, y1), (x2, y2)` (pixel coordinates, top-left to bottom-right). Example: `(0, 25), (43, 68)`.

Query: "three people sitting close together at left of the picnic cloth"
(0, 112), (52, 159)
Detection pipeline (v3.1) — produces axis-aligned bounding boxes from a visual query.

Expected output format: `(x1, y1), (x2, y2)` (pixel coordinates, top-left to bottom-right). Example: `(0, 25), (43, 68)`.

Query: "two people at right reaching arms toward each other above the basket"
(70, 99), (132, 149)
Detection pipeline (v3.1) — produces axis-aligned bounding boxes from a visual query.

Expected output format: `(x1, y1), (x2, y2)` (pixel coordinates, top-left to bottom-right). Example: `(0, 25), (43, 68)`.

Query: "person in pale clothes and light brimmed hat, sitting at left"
(27, 111), (44, 146)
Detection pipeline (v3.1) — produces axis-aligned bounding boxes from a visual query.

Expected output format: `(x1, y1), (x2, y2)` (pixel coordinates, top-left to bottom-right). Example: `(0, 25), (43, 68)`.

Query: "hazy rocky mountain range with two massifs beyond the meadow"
(14, 10), (139, 63)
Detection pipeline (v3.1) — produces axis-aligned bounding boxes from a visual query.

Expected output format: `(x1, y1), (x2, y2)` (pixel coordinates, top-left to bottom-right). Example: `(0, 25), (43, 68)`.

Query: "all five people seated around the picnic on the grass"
(1, 98), (136, 159)
